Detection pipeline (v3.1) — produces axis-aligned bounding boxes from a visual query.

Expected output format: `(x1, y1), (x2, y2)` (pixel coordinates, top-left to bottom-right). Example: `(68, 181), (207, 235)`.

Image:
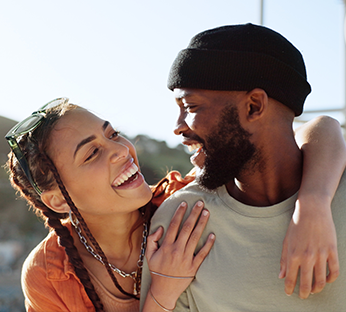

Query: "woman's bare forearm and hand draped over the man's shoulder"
(279, 116), (346, 298)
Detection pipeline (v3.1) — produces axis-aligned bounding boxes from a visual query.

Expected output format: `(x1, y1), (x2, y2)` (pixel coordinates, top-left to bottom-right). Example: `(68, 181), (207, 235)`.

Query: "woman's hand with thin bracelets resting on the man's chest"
(143, 201), (215, 311)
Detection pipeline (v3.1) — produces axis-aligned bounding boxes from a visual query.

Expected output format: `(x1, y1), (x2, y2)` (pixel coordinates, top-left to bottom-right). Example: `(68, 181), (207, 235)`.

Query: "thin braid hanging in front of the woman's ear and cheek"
(42, 155), (139, 300)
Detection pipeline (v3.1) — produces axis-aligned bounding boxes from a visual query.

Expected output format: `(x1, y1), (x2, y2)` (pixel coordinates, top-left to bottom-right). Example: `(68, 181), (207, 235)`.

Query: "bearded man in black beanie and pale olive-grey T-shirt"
(143, 24), (346, 312)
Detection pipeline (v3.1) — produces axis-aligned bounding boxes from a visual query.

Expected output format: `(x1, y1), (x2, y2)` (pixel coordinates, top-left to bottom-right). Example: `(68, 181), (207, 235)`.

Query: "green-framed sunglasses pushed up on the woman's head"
(5, 98), (69, 195)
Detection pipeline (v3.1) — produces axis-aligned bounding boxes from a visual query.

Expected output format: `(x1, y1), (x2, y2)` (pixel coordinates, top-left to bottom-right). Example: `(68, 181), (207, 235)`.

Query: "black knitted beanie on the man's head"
(168, 24), (311, 116)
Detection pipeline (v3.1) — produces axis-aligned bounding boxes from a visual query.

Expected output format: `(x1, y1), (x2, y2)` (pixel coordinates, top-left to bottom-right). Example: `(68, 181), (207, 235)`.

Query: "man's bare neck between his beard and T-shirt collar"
(226, 142), (303, 207)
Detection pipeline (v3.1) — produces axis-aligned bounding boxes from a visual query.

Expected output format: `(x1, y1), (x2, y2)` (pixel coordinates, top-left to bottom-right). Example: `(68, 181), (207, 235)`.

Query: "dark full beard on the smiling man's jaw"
(196, 105), (256, 190)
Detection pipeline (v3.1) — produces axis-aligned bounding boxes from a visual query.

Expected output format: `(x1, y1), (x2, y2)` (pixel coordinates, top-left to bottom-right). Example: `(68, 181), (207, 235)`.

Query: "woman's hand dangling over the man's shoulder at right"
(279, 194), (339, 299)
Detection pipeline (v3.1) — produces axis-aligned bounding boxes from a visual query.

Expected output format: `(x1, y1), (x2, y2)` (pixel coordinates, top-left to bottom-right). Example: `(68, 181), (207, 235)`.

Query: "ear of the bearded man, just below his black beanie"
(247, 88), (268, 122)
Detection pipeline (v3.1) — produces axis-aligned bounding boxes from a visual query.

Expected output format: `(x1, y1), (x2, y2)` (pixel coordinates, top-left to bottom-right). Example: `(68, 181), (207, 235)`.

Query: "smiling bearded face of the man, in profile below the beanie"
(174, 89), (256, 190)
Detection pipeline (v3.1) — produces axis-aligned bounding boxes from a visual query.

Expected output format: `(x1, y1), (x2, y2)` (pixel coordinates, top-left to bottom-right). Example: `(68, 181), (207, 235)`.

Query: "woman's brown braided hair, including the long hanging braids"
(6, 103), (147, 311)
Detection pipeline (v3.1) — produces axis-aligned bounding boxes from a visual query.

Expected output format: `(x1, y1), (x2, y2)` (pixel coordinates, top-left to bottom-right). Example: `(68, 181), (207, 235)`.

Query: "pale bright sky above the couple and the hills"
(0, 0), (345, 147)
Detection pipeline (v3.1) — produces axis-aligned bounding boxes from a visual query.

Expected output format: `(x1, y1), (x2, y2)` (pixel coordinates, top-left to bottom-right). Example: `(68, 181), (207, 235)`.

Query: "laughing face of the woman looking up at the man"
(48, 108), (152, 215)
